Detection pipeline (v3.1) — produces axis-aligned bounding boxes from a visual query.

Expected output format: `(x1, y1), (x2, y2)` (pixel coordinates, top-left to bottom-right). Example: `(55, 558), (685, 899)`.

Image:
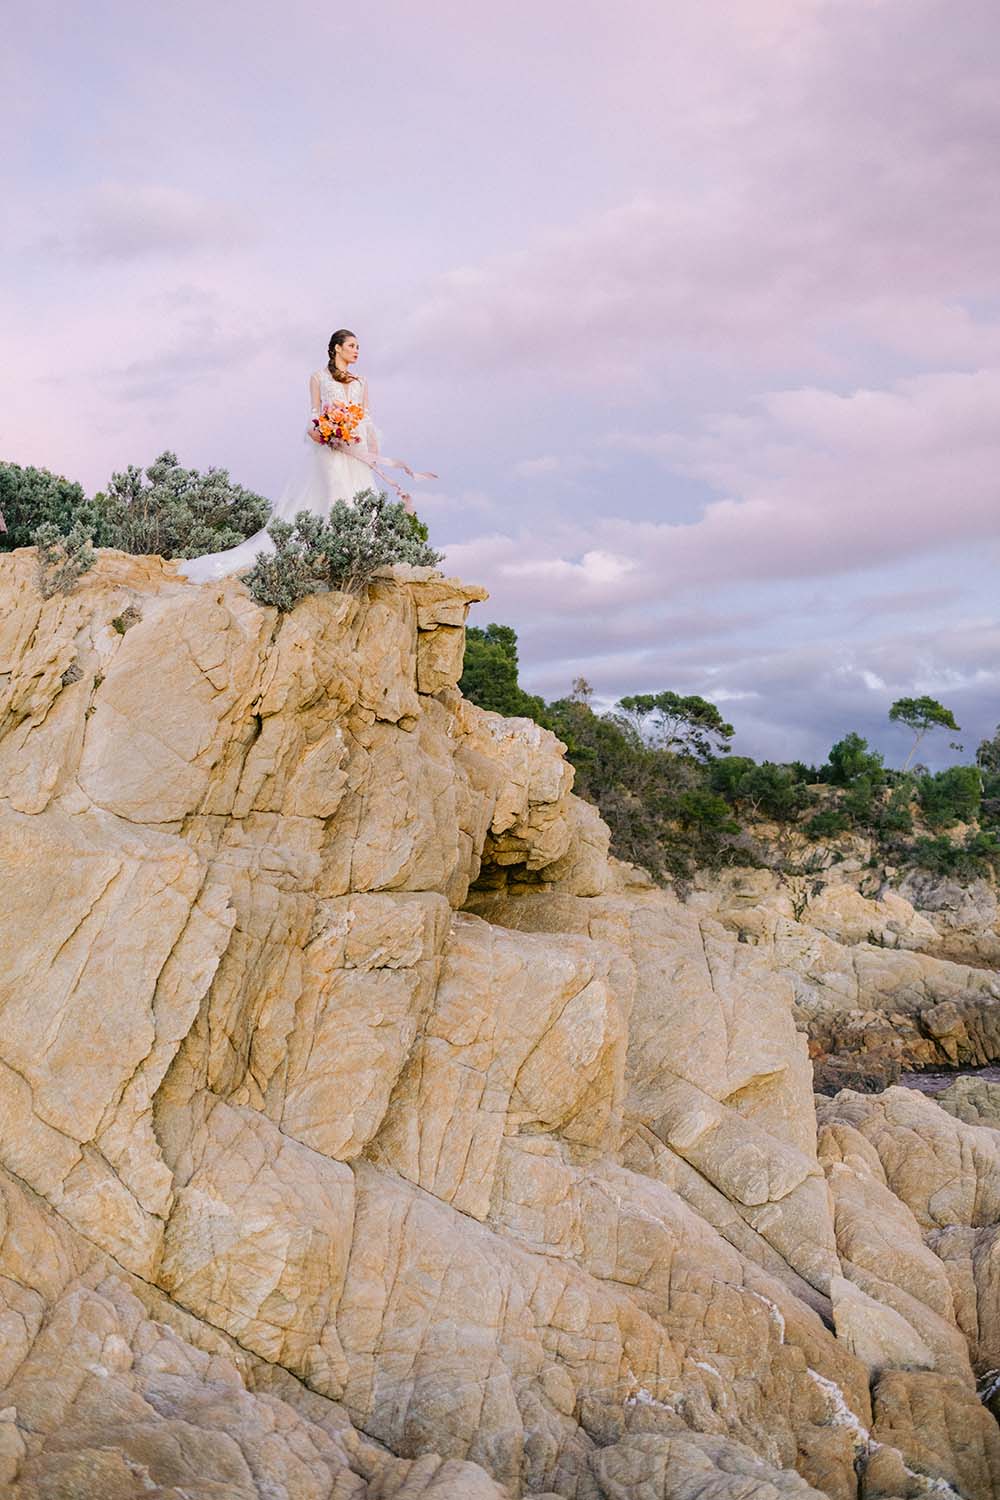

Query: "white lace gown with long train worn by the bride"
(180, 369), (379, 584)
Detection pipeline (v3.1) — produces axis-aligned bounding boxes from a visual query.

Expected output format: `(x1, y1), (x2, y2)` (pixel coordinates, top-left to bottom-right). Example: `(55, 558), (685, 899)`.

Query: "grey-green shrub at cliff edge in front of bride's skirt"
(243, 489), (441, 611)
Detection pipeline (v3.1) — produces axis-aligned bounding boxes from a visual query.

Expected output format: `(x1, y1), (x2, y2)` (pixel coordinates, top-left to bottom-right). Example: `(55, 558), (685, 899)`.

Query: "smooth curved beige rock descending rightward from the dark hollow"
(475, 890), (840, 1290)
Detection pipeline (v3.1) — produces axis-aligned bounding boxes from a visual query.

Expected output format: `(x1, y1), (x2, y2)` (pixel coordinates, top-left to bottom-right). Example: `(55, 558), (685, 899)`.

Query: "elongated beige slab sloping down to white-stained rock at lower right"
(490, 1136), (868, 1481)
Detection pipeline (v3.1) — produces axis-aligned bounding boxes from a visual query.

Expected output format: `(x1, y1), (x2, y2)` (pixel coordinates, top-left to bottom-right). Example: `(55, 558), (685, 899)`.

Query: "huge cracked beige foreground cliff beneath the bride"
(0, 552), (1000, 1500)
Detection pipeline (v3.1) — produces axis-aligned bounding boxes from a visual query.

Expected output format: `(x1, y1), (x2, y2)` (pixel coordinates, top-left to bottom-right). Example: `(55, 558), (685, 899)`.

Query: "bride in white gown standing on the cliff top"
(180, 329), (407, 584)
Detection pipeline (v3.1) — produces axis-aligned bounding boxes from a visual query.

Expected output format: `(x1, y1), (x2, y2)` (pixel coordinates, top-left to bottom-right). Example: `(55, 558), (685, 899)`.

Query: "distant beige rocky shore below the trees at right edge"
(693, 864), (1000, 1094)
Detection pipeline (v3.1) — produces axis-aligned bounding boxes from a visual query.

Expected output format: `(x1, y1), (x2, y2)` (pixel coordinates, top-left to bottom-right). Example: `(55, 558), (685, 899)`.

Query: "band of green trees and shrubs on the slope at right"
(459, 624), (1000, 879)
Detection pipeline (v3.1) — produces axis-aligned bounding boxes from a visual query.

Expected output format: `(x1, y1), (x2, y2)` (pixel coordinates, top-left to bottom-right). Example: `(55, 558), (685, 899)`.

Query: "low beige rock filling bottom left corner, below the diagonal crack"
(0, 1260), (504, 1500)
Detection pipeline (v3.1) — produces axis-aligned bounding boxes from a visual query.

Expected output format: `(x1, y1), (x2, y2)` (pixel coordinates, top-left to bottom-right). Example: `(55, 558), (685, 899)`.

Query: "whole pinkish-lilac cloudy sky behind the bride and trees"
(0, 0), (1000, 765)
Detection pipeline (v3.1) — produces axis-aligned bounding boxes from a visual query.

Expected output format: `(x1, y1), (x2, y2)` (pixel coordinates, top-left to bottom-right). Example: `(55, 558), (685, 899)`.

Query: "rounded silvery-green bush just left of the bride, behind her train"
(94, 453), (271, 558)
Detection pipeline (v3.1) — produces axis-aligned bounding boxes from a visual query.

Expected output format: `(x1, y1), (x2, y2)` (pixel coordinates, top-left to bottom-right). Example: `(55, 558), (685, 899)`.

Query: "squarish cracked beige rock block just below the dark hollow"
(372, 917), (625, 1220)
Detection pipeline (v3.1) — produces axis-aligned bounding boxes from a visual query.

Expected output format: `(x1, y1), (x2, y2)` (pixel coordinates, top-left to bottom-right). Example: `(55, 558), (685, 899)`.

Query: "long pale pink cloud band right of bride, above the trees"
(448, 369), (1000, 615)
